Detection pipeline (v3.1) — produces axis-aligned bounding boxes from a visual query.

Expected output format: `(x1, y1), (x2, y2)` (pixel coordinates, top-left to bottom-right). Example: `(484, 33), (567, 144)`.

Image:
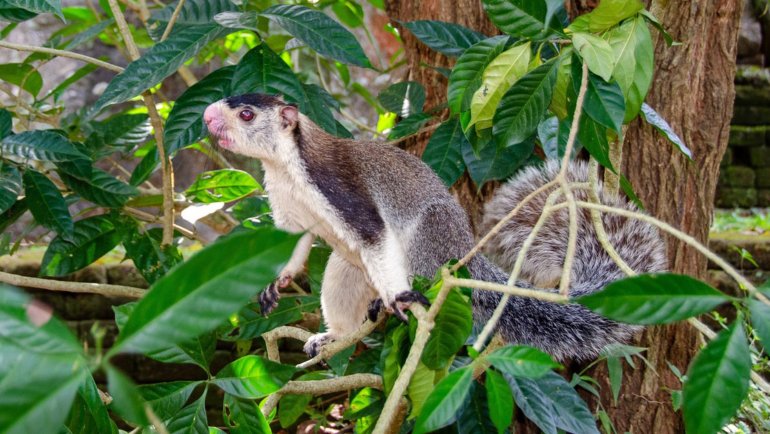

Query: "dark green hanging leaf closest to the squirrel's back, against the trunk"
(422, 118), (470, 187)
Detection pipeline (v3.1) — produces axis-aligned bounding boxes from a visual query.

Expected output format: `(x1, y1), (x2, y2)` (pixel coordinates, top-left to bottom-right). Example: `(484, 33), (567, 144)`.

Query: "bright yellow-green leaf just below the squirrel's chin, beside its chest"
(184, 169), (262, 203)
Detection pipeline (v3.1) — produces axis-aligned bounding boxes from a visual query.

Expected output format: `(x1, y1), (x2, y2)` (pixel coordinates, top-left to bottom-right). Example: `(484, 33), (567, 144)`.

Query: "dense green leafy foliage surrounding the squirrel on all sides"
(0, 0), (770, 433)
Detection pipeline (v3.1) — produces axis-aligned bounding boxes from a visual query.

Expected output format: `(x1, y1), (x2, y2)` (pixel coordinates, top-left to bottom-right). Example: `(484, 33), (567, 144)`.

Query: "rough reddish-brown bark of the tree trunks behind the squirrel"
(386, 0), (741, 433)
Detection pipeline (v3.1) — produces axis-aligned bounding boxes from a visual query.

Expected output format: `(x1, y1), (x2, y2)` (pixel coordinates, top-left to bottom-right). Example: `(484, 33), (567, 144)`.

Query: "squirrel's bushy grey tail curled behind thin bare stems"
(468, 162), (666, 360)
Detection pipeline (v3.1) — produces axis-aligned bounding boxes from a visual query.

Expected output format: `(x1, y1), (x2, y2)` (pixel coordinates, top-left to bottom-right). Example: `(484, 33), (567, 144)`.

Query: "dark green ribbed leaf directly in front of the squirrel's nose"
(168, 66), (236, 155)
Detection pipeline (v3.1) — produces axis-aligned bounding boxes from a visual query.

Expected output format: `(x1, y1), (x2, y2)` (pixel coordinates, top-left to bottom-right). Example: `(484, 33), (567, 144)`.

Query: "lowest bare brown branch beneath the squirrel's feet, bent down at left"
(262, 374), (382, 416)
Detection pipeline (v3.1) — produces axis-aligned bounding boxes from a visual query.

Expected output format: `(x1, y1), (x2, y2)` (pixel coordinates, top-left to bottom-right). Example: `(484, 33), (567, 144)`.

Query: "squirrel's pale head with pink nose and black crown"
(203, 93), (299, 159)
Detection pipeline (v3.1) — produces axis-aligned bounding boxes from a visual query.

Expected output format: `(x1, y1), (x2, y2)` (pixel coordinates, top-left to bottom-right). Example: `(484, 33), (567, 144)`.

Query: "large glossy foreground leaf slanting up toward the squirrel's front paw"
(111, 228), (298, 354)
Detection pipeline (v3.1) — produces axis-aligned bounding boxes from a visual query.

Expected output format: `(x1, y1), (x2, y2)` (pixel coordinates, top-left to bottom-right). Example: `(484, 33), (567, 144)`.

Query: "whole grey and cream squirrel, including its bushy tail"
(204, 95), (663, 359)
